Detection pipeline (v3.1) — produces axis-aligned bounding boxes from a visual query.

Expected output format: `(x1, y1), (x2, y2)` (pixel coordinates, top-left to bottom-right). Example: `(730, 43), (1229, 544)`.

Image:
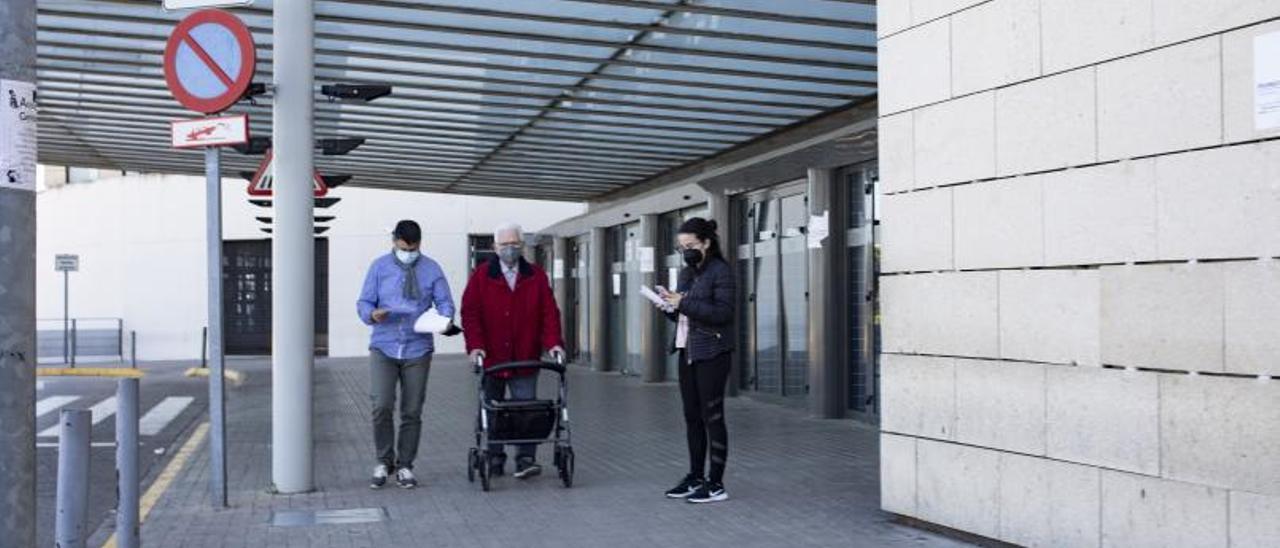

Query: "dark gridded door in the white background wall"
(223, 238), (329, 356)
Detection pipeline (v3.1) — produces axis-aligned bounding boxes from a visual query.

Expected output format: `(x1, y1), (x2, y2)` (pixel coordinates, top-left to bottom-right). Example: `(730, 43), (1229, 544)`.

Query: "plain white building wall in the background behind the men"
(37, 169), (585, 360)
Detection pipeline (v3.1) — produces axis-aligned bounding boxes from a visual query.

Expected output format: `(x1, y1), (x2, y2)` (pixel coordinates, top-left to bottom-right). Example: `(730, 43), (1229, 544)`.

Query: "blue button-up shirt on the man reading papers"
(356, 254), (454, 360)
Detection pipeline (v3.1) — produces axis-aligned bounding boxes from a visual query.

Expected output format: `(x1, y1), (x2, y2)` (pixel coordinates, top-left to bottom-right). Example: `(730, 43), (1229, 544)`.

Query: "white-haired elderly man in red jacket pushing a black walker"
(462, 224), (564, 479)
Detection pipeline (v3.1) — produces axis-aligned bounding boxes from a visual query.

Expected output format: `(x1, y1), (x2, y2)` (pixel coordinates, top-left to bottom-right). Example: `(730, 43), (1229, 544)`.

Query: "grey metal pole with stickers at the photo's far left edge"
(0, 0), (38, 548)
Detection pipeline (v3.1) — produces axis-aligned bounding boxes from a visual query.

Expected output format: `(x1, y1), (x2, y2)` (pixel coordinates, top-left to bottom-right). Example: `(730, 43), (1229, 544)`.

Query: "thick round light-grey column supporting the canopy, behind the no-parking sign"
(271, 1), (315, 493)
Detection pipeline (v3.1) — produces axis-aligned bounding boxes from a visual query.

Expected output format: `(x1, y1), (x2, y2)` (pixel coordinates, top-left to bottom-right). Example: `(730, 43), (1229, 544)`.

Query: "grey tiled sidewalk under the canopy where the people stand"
(122, 356), (960, 548)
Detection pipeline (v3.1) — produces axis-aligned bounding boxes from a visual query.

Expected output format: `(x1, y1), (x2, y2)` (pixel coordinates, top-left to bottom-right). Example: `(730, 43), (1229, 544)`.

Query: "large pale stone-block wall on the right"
(879, 0), (1280, 547)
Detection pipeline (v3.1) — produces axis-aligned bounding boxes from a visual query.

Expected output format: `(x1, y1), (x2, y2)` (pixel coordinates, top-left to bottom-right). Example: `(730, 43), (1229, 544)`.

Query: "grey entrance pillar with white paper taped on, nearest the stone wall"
(808, 169), (847, 419)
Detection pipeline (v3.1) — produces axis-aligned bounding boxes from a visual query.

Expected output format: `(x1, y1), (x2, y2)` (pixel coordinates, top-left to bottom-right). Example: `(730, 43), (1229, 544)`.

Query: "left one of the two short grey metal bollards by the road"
(54, 410), (92, 548)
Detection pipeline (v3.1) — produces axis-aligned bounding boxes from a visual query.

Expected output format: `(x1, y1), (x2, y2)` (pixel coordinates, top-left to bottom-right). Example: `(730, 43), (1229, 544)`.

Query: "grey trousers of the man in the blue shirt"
(369, 350), (431, 469)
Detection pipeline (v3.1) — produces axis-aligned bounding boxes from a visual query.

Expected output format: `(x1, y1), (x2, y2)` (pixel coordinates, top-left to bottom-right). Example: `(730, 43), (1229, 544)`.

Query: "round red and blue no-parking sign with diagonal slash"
(164, 9), (257, 114)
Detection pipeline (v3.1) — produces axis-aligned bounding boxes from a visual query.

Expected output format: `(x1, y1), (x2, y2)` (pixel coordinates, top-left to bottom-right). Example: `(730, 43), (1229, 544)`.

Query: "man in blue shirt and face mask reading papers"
(356, 220), (454, 489)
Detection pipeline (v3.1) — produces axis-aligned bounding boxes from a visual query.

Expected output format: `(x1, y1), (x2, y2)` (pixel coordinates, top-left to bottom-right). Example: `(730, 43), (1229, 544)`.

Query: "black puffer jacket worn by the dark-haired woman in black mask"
(667, 257), (737, 361)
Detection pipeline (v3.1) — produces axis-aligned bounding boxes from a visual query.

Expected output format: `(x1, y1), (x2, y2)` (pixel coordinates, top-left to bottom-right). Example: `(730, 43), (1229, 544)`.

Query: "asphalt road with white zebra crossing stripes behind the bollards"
(36, 364), (209, 547)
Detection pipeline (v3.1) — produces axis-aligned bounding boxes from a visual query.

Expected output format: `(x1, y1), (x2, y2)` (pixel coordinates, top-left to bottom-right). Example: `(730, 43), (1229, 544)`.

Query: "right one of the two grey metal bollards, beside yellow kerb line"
(115, 379), (140, 548)
